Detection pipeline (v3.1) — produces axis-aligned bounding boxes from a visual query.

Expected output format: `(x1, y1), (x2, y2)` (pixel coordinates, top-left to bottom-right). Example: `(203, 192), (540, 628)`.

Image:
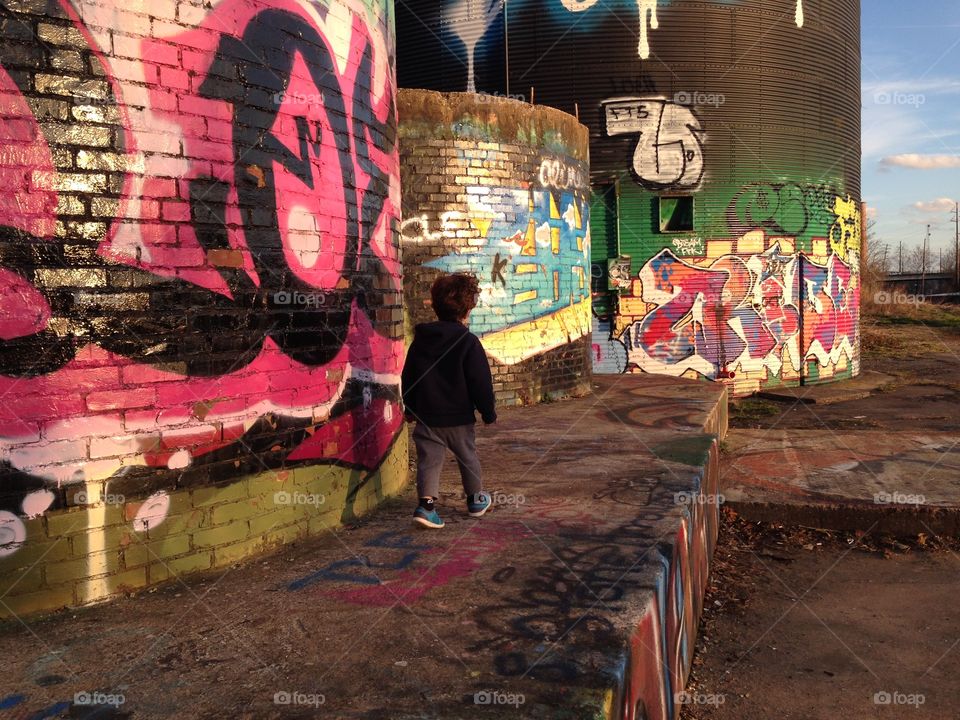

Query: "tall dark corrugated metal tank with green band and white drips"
(397, 0), (862, 394)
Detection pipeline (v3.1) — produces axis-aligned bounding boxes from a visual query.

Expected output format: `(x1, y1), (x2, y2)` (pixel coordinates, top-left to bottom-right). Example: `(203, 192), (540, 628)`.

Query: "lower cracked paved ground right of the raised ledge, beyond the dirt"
(721, 310), (960, 535)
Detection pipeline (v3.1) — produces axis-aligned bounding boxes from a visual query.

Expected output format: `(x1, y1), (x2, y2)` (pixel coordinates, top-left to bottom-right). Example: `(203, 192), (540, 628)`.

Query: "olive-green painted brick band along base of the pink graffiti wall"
(0, 456), (408, 617)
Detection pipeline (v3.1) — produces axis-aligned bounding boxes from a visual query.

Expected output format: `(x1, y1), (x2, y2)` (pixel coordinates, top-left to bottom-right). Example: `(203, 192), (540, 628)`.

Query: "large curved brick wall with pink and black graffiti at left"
(0, 0), (406, 616)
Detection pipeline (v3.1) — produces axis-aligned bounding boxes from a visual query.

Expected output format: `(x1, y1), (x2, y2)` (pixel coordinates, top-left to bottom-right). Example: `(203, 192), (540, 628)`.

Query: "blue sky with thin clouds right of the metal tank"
(862, 0), (960, 264)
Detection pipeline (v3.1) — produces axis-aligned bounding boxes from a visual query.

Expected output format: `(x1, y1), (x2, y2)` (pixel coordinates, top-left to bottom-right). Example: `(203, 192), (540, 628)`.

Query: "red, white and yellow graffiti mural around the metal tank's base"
(594, 188), (861, 393)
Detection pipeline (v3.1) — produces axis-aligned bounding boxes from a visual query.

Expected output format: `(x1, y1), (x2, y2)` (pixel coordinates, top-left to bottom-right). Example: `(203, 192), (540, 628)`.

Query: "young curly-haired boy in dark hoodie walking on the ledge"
(401, 273), (497, 528)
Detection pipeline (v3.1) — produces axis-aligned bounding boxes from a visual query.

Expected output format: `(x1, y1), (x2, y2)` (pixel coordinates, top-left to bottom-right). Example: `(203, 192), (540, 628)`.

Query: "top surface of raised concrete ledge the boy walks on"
(0, 376), (726, 720)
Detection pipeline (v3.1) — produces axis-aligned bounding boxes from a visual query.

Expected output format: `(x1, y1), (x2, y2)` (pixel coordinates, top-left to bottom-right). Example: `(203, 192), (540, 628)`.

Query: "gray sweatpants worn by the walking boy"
(413, 422), (483, 498)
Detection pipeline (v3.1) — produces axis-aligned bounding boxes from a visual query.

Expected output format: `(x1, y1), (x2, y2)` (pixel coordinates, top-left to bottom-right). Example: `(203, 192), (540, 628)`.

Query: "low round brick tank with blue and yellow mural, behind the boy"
(399, 90), (591, 404)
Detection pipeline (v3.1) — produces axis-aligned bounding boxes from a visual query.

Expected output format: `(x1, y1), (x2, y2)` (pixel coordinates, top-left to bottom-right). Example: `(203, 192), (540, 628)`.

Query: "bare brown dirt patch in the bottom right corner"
(681, 510), (960, 720)
